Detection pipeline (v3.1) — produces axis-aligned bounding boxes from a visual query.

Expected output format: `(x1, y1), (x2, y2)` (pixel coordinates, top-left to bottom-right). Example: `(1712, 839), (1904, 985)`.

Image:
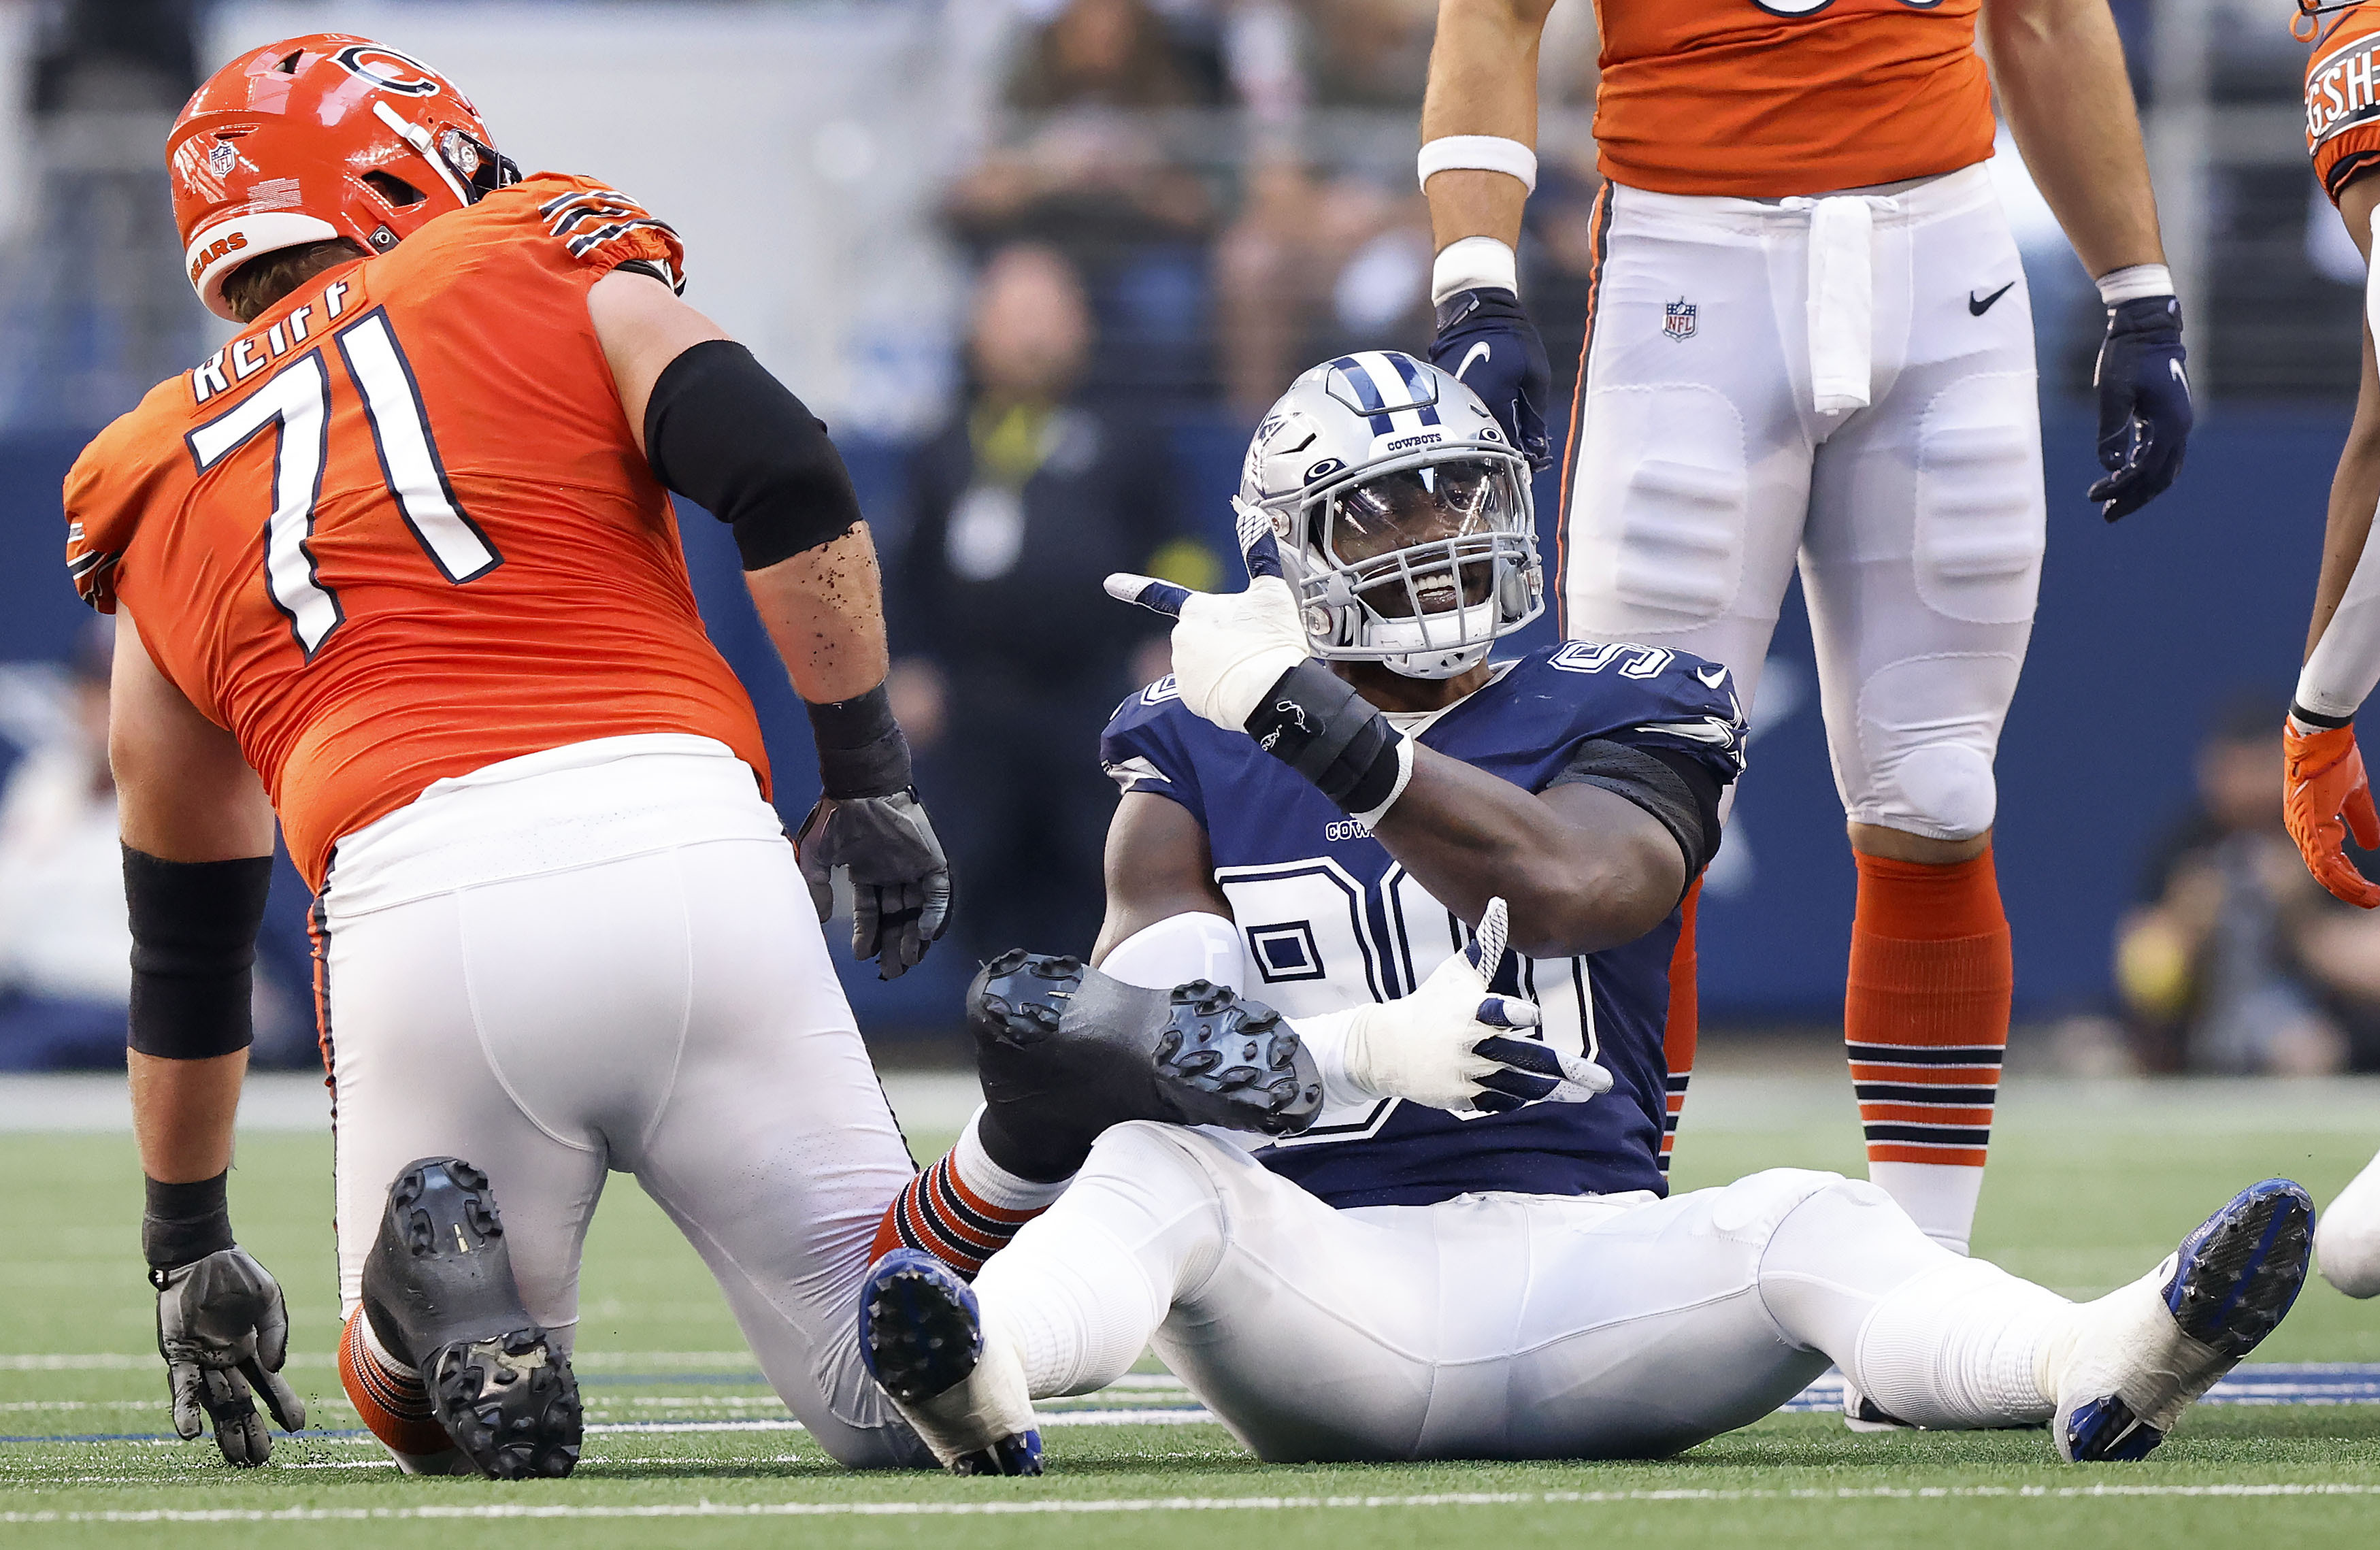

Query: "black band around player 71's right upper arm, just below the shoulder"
(645, 338), (859, 572)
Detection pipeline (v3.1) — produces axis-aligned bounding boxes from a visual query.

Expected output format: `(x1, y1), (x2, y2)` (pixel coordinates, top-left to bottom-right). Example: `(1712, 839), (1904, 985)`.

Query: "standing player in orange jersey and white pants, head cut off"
(1421, 0), (2189, 1323)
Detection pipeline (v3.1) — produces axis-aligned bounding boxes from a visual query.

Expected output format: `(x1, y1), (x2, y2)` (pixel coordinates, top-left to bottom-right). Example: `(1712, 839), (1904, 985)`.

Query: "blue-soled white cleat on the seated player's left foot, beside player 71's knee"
(859, 1248), (1040, 1474)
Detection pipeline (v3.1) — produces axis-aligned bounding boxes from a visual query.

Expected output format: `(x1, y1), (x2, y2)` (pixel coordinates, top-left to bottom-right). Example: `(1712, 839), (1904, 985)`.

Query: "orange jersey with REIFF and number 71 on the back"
(67, 174), (766, 888)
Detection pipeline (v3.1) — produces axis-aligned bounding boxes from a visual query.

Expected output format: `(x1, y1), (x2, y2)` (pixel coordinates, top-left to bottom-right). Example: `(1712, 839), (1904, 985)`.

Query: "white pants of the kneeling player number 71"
(314, 736), (933, 1467)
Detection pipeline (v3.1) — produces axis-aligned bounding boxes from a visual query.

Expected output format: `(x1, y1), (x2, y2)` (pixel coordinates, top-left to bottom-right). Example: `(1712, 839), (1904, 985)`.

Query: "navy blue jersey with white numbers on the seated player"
(1100, 640), (1745, 1207)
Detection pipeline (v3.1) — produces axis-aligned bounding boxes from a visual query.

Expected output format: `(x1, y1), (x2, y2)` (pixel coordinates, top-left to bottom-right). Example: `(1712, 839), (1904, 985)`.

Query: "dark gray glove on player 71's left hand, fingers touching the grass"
(150, 1245), (305, 1469)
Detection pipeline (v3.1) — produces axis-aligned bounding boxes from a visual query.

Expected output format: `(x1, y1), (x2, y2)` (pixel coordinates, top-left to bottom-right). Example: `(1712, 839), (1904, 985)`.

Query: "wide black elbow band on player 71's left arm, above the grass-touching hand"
(124, 845), (274, 1059)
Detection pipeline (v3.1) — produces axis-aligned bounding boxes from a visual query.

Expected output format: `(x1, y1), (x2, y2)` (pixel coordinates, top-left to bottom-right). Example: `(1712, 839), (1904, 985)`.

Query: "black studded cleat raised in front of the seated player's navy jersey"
(966, 948), (1323, 1178)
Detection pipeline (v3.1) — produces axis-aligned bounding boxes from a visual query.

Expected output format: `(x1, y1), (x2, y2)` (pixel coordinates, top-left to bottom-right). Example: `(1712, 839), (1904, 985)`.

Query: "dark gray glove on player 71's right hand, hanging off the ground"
(793, 791), (950, 978)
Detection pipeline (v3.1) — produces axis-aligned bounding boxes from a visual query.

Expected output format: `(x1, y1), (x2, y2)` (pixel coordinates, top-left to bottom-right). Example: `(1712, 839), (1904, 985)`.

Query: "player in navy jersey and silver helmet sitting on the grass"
(861, 352), (2313, 1469)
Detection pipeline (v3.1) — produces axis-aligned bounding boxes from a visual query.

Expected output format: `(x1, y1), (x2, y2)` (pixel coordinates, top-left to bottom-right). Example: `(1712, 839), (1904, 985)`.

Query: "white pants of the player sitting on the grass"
(976, 1124), (2073, 1462)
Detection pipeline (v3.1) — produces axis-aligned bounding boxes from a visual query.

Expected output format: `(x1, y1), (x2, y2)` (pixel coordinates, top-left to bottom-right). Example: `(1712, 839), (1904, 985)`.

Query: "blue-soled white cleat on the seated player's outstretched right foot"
(2054, 1178), (2313, 1464)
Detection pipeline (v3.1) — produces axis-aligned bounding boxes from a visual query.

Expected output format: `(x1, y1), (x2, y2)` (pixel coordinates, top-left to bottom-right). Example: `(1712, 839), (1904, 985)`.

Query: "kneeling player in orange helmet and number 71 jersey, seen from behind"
(84, 35), (950, 1479)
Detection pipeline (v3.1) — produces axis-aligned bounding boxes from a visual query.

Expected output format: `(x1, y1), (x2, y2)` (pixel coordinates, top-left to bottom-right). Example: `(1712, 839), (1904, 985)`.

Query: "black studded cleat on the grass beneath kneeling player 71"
(364, 1157), (581, 1481)
